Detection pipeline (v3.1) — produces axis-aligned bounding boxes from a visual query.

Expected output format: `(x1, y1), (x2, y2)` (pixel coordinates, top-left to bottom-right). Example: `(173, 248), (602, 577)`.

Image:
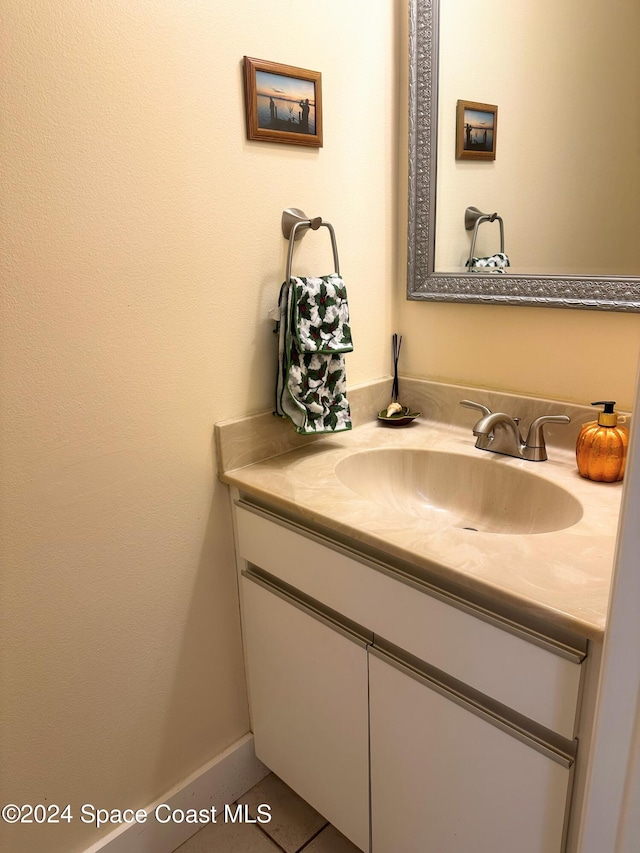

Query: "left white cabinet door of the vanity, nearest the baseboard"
(242, 575), (369, 851)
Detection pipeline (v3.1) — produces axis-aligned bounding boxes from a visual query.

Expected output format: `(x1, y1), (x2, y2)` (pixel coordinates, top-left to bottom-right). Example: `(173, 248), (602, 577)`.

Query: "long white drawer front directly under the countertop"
(235, 501), (581, 739)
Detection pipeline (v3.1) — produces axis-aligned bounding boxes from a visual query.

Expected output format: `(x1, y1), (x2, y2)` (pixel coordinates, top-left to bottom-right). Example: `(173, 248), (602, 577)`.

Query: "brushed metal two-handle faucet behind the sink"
(460, 400), (571, 462)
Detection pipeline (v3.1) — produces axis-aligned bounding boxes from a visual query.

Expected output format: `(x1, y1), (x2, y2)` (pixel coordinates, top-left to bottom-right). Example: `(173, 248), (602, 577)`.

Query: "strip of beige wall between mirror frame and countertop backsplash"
(398, 297), (640, 409)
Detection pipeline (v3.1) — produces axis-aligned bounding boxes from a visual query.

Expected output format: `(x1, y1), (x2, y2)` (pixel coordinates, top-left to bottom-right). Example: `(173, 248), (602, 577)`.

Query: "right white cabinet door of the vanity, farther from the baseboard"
(369, 654), (570, 853)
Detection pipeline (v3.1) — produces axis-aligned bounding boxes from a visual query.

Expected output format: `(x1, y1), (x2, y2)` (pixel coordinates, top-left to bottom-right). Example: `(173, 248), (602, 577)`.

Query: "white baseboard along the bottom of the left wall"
(85, 734), (269, 853)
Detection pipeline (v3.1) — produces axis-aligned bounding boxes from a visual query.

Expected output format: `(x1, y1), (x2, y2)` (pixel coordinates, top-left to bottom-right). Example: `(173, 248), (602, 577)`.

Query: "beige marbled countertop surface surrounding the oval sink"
(220, 420), (622, 639)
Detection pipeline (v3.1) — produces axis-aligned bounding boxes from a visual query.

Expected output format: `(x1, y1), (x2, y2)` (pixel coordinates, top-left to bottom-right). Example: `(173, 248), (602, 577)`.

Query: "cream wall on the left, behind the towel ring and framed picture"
(0, 0), (397, 853)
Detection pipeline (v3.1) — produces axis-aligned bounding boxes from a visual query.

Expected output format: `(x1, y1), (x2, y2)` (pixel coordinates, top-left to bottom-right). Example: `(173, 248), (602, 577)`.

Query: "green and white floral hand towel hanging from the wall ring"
(276, 273), (353, 435)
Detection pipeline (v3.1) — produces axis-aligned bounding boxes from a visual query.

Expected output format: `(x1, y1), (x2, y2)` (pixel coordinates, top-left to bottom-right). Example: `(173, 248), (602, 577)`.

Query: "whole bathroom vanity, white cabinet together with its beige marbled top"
(217, 383), (621, 853)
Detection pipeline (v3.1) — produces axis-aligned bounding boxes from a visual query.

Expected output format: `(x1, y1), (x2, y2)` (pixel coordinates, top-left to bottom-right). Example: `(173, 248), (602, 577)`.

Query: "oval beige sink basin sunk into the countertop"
(335, 448), (582, 534)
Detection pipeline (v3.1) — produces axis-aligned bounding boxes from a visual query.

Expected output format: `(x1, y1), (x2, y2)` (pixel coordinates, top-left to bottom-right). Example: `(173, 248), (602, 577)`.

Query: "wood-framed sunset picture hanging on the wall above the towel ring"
(244, 56), (322, 148)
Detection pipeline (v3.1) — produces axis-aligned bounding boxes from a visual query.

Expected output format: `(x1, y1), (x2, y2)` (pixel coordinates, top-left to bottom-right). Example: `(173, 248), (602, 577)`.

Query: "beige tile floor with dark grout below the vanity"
(174, 773), (360, 853)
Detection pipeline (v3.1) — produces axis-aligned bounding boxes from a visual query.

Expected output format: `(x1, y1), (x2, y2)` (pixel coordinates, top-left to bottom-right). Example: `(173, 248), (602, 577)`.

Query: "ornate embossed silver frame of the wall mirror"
(407, 0), (640, 312)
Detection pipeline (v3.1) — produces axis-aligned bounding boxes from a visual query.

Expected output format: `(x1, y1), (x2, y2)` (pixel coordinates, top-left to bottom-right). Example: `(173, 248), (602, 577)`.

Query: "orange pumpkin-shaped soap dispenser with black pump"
(576, 400), (629, 483)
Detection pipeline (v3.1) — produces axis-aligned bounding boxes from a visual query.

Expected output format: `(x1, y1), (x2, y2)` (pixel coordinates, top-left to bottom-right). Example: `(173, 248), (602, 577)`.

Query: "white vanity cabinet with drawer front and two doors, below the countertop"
(234, 499), (586, 853)
